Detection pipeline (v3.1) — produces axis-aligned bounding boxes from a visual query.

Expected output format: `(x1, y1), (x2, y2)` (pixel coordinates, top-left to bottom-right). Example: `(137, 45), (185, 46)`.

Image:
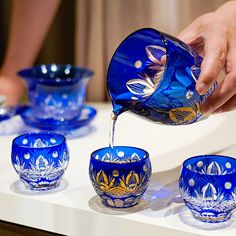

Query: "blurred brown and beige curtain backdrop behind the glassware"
(0, 0), (226, 101)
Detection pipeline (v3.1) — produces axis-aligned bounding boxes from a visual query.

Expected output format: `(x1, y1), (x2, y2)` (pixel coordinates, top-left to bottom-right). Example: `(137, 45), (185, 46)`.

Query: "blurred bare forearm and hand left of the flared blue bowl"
(0, 0), (60, 105)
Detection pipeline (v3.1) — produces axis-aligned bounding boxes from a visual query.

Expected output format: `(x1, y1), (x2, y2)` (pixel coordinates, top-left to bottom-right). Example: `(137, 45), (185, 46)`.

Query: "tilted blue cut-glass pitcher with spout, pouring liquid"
(107, 28), (217, 125)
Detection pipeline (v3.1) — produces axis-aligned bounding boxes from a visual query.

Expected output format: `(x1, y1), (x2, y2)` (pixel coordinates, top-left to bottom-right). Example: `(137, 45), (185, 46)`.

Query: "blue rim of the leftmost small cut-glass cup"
(12, 131), (66, 150)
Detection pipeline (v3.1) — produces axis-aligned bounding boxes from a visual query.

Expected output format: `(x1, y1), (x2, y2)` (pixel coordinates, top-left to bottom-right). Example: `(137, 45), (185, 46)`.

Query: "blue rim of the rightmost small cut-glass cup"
(181, 154), (236, 176)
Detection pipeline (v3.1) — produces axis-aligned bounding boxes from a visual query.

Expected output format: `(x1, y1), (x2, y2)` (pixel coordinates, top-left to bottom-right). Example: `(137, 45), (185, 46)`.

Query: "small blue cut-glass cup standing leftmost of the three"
(11, 132), (69, 191)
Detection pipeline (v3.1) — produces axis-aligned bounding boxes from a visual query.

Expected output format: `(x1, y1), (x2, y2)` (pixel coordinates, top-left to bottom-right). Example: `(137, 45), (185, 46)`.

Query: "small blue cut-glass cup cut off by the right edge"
(179, 155), (236, 223)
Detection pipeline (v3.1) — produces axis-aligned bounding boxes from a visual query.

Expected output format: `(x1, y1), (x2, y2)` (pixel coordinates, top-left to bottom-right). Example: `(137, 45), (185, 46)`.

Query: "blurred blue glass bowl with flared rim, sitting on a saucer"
(18, 64), (93, 123)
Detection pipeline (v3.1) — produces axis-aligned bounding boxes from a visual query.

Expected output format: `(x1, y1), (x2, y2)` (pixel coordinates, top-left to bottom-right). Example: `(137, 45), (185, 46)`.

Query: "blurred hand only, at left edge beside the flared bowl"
(0, 74), (25, 106)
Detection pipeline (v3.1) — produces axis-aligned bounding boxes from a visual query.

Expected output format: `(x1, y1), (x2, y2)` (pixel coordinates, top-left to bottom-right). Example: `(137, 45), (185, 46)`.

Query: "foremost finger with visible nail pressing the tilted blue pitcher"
(196, 32), (227, 95)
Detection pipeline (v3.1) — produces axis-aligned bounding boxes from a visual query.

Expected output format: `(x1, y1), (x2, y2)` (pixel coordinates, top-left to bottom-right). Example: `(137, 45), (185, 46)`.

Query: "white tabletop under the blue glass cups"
(0, 104), (236, 236)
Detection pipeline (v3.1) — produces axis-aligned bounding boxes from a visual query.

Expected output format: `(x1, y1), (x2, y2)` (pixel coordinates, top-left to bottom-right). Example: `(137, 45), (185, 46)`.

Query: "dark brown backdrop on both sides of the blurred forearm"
(0, 0), (76, 66)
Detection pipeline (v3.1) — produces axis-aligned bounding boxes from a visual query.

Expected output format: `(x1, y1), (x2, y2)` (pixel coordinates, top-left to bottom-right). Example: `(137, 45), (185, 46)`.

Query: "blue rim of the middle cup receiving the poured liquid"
(90, 145), (150, 165)
